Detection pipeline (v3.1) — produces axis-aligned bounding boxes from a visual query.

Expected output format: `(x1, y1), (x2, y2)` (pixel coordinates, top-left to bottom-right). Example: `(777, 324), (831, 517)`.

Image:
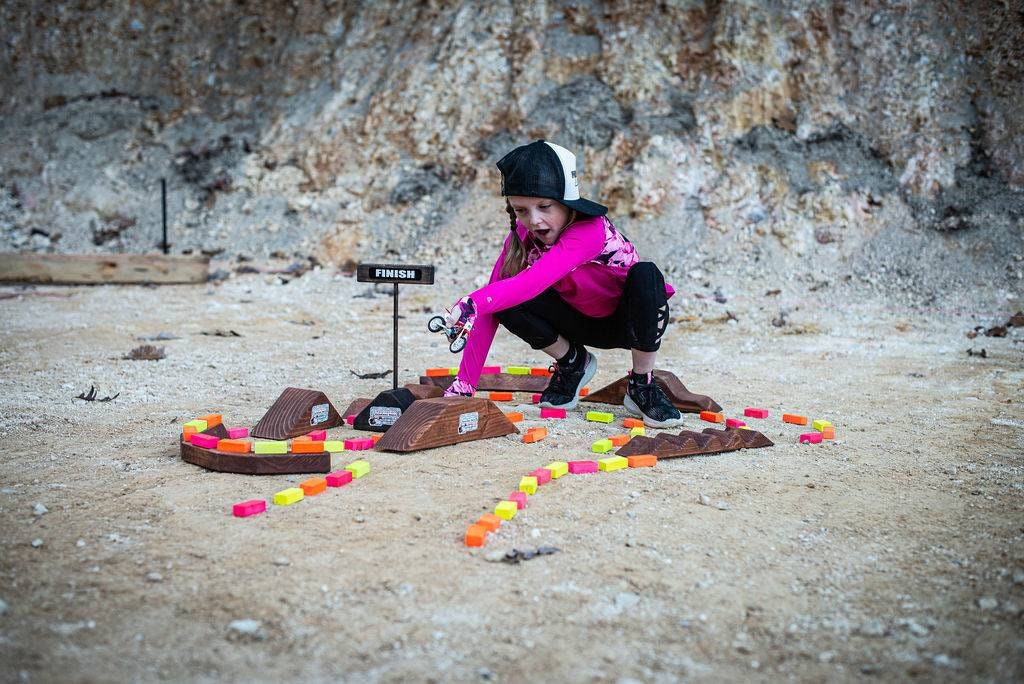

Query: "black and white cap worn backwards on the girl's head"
(498, 140), (608, 216)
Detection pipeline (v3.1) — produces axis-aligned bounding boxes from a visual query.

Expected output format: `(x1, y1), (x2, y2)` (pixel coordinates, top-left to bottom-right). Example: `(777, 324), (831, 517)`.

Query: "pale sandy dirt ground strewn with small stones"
(0, 270), (1024, 682)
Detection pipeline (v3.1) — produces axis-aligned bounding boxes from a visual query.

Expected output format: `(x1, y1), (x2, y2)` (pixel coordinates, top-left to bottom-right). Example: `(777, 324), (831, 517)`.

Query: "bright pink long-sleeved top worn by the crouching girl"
(459, 216), (675, 387)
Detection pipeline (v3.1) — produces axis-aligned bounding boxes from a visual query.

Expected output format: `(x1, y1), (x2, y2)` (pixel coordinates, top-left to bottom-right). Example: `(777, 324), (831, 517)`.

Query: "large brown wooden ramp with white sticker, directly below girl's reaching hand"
(377, 396), (519, 453)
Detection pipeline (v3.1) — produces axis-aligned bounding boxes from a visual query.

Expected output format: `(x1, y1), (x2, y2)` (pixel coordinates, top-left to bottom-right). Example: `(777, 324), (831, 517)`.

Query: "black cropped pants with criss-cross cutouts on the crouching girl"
(497, 261), (669, 351)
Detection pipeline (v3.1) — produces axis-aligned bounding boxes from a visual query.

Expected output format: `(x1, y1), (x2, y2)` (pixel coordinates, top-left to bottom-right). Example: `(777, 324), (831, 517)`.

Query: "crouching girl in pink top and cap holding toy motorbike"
(445, 140), (682, 427)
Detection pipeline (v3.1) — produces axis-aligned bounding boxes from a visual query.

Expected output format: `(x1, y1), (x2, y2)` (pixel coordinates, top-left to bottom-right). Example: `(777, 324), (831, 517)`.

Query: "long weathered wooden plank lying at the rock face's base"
(0, 252), (210, 285)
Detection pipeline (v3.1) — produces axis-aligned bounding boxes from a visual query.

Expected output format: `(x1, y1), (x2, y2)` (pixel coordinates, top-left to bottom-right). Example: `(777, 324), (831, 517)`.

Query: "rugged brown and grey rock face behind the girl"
(0, 0), (1024, 298)
